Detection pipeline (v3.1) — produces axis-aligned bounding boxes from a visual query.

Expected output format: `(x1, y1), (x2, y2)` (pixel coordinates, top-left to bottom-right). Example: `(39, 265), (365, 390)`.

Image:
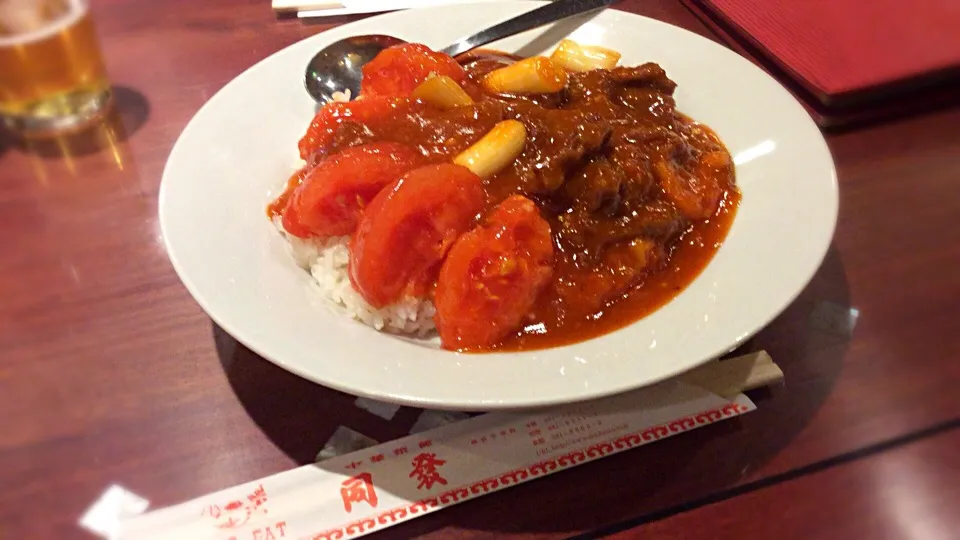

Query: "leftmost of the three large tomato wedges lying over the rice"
(283, 142), (423, 238)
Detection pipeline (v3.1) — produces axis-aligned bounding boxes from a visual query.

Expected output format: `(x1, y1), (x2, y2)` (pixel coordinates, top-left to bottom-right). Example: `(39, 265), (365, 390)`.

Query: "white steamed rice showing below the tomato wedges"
(274, 218), (436, 337)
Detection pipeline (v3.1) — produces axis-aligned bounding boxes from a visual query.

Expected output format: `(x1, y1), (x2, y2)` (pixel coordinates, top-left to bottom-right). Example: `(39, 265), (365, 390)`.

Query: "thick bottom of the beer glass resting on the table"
(2, 88), (112, 138)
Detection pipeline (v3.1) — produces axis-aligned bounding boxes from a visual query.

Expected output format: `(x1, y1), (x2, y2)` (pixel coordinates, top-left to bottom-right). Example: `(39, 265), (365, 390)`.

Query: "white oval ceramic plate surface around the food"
(160, 1), (838, 410)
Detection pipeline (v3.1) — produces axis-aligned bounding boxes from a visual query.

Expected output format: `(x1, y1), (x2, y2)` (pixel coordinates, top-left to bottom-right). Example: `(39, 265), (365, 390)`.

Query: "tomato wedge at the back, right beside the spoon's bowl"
(360, 43), (466, 96)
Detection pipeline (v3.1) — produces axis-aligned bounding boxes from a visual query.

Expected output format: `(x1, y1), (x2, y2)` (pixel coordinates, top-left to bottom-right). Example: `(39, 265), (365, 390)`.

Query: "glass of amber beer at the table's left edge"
(0, 0), (110, 137)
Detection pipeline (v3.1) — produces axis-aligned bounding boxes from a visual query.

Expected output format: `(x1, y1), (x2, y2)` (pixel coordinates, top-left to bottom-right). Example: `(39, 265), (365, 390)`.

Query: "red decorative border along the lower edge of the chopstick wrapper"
(311, 403), (750, 540)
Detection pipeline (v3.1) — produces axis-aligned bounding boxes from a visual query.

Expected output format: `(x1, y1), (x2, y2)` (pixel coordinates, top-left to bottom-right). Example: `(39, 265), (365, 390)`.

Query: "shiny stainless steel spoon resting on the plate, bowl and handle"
(304, 0), (616, 103)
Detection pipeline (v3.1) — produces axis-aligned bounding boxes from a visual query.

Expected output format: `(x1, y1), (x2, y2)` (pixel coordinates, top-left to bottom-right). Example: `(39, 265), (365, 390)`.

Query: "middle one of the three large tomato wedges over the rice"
(350, 164), (483, 308)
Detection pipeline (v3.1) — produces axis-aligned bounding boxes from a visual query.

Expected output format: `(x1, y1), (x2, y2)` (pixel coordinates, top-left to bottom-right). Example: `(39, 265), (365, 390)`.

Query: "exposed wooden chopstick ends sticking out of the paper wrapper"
(679, 351), (783, 399)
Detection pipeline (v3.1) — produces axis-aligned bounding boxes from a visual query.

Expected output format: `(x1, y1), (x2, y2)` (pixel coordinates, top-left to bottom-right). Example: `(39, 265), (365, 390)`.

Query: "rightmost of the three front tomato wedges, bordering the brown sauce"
(434, 195), (553, 350)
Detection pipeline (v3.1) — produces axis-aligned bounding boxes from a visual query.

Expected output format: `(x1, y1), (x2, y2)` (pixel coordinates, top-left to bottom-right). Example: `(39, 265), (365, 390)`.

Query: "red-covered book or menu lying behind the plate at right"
(685, 0), (960, 124)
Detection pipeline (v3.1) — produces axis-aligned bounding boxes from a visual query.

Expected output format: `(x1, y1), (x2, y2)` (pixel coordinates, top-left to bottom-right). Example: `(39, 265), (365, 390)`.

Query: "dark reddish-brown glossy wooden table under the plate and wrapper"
(0, 0), (960, 539)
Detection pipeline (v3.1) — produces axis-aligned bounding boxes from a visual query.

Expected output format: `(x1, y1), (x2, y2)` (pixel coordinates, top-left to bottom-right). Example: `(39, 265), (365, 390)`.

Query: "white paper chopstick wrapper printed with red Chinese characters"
(120, 380), (755, 540)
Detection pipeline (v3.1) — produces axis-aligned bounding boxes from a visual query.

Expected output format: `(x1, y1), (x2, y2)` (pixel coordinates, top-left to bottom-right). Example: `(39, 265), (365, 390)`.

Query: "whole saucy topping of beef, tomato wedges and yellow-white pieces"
(269, 42), (740, 351)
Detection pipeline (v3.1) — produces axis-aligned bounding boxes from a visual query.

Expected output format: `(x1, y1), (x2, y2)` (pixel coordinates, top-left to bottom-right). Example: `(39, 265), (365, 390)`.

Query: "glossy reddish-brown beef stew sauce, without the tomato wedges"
(268, 48), (740, 351)
